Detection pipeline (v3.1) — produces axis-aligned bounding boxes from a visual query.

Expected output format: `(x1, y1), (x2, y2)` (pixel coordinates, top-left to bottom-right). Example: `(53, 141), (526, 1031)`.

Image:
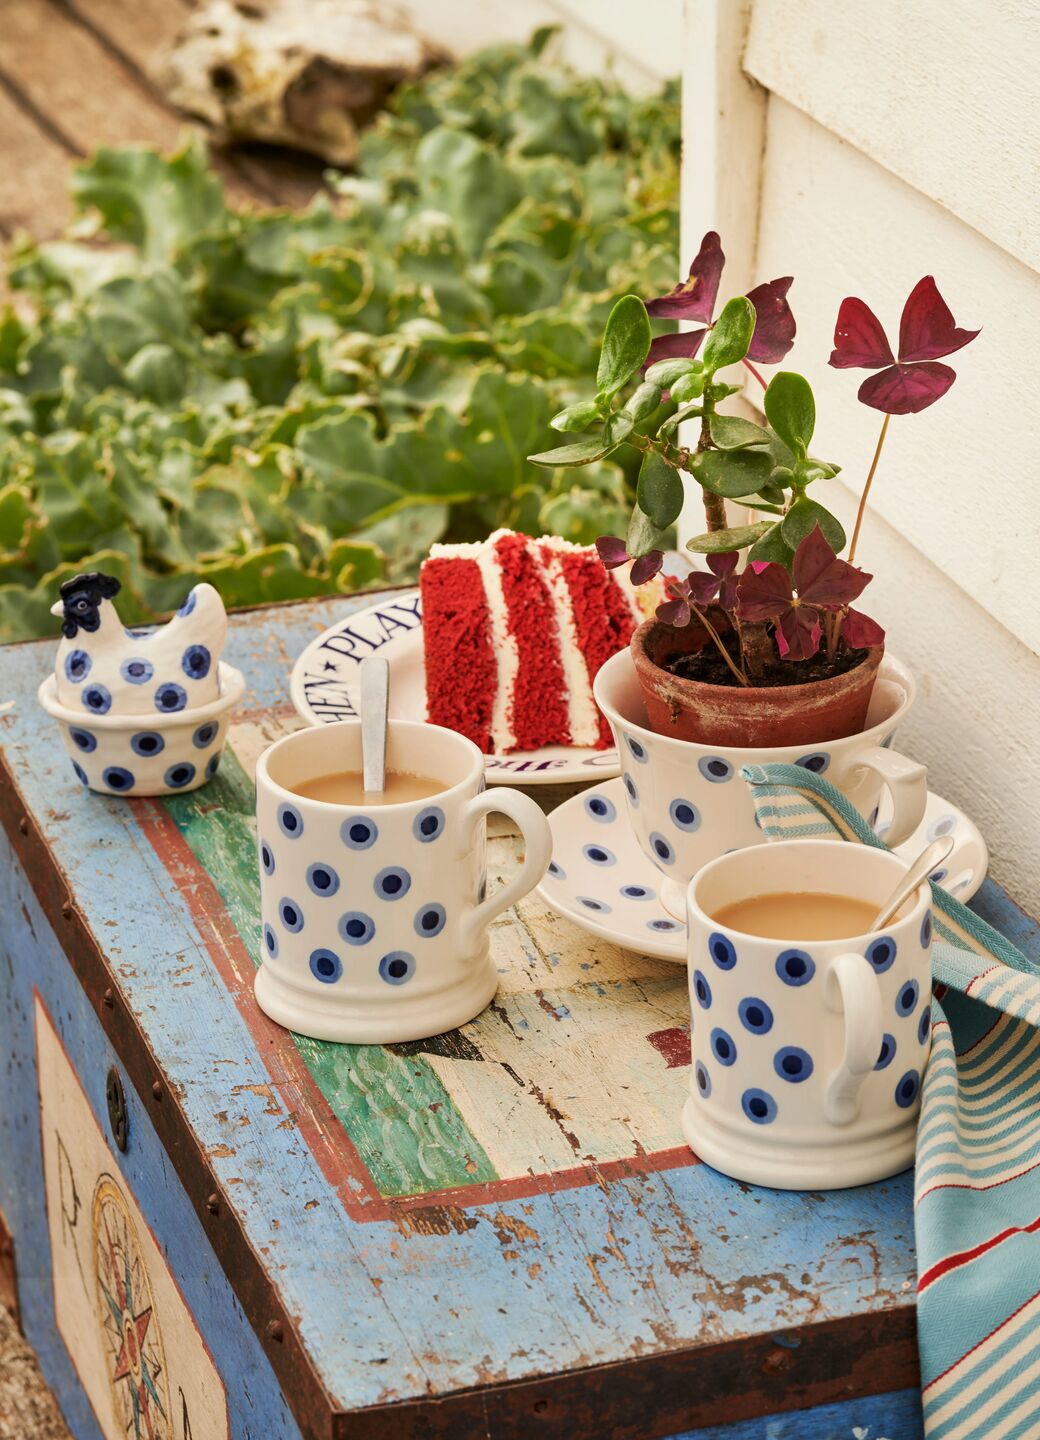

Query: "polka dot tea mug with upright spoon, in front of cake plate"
(255, 720), (552, 1044)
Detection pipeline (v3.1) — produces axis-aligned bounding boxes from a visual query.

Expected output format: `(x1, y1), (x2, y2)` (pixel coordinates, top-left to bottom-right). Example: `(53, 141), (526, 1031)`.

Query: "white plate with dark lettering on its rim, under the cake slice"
(290, 590), (621, 785)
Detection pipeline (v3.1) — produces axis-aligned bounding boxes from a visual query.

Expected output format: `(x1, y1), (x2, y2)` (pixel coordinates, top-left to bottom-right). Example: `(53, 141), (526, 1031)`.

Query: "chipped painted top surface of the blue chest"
(0, 600), (956, 1422)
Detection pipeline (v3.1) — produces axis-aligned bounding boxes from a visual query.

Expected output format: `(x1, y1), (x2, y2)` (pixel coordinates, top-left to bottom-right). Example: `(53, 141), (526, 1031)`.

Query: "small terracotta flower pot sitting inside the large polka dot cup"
(632, 621), (884, 747)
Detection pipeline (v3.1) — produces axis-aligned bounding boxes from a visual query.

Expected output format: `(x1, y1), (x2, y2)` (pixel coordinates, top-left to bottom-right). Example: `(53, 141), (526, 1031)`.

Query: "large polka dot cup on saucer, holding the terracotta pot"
(593, 649), (928, 920)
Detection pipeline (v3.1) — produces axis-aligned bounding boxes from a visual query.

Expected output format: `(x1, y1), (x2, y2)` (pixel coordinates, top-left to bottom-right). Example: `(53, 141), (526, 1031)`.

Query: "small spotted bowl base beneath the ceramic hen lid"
(39, 661), (245, 798)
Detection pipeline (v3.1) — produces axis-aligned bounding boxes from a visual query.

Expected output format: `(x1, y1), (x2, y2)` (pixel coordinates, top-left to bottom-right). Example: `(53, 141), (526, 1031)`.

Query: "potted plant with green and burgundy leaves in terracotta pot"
(530, 232), (978, 746)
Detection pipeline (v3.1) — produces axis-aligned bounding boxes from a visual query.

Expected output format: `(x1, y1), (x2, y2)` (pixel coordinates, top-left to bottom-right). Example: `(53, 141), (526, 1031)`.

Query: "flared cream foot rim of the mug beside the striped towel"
(683, 1096), (918, 1189)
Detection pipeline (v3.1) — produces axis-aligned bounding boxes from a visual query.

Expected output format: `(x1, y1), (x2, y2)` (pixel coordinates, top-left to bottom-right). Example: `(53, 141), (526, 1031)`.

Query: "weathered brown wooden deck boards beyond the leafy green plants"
(0, 0), (323, 239)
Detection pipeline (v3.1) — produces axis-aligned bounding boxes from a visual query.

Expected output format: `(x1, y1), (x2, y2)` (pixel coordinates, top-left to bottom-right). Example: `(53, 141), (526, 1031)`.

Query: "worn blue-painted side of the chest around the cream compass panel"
(0, 829), (300, 1440)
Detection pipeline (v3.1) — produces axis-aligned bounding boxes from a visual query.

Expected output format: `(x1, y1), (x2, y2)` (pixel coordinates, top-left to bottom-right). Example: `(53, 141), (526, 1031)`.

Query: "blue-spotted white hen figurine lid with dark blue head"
(52, 570), (228, 716)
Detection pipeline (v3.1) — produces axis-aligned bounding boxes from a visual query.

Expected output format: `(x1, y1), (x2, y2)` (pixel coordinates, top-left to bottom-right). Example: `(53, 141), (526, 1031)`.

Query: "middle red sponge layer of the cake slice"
(494, 534), (570, 750)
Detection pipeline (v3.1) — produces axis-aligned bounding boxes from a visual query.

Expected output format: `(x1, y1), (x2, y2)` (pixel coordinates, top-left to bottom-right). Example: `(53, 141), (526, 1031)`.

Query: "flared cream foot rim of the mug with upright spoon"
(254, 950), (498, 1045)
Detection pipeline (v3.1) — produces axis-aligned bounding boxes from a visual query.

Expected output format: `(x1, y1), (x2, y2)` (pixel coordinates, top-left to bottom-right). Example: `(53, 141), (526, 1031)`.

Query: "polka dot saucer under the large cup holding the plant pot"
(537, 779), (988, 963)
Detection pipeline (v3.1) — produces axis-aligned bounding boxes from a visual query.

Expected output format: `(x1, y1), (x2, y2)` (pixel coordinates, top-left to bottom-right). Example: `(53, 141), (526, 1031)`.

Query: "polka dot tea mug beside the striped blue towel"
(683, 840), (932, 1189)
